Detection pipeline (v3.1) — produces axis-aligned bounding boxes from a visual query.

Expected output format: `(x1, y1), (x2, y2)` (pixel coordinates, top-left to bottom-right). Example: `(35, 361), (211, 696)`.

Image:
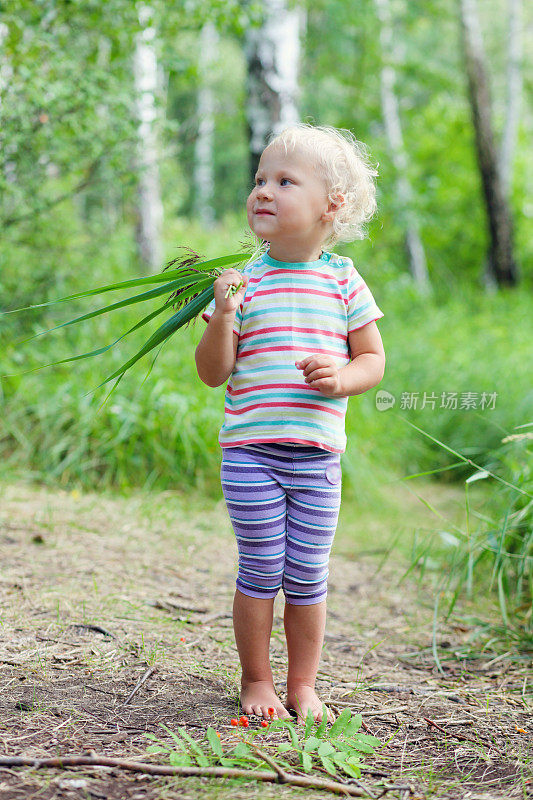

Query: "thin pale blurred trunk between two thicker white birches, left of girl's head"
(194, 22), (218, 226)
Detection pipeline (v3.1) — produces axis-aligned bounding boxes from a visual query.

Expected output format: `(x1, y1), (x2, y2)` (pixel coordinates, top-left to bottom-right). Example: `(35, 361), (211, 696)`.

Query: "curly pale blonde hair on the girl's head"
(267, 122), (378, 245)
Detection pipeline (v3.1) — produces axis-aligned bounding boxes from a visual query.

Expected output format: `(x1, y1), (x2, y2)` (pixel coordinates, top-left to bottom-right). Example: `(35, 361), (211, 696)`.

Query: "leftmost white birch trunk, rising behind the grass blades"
(133, 4), (163, 271)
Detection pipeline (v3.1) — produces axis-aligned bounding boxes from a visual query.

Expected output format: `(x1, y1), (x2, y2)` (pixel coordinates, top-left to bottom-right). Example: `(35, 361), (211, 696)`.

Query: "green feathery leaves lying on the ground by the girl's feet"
(145, 705), (381, 778)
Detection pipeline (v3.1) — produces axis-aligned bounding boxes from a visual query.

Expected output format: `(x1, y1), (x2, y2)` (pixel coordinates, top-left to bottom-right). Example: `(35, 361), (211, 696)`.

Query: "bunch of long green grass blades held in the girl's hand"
(3, 234), (265, 403)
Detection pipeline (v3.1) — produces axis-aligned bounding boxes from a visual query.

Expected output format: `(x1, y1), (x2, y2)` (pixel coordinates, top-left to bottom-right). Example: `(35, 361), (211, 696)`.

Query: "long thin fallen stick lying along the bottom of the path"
(0, 748), (367, 797)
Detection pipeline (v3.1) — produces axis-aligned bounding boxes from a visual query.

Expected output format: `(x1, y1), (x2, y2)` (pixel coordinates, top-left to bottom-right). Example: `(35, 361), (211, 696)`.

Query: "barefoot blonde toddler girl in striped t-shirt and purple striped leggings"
(195, 123), (385, 724)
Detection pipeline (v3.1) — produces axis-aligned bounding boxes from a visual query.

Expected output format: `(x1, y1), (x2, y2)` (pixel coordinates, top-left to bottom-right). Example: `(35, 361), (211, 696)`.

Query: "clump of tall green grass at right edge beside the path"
(410, 422), (533, 655)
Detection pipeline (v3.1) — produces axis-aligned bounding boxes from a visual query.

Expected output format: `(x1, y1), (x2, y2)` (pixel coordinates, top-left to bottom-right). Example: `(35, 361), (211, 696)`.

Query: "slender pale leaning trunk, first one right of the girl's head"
(375, 0), (431, 294)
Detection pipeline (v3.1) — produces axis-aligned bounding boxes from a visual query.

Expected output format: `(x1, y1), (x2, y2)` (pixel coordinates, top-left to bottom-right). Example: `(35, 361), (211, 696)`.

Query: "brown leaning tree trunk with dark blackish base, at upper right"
(460, 0), (518, 286)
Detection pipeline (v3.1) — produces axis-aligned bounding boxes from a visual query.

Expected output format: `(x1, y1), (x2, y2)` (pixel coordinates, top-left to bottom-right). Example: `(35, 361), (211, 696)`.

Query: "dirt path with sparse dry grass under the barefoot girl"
(0, 484), (533, 800)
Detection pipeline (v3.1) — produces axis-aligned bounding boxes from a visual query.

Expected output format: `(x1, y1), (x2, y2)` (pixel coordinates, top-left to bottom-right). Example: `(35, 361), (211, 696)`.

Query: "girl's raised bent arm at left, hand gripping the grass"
(194, 269), (248, 388)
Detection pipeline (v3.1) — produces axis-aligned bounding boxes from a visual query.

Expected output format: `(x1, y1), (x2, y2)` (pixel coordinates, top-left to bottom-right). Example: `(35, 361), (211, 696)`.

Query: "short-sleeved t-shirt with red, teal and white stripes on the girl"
(202, 253), (383, 453)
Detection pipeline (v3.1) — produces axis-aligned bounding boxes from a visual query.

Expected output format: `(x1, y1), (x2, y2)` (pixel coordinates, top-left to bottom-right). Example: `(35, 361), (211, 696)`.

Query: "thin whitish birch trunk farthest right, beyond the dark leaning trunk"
(500, 0), (522, 199)
